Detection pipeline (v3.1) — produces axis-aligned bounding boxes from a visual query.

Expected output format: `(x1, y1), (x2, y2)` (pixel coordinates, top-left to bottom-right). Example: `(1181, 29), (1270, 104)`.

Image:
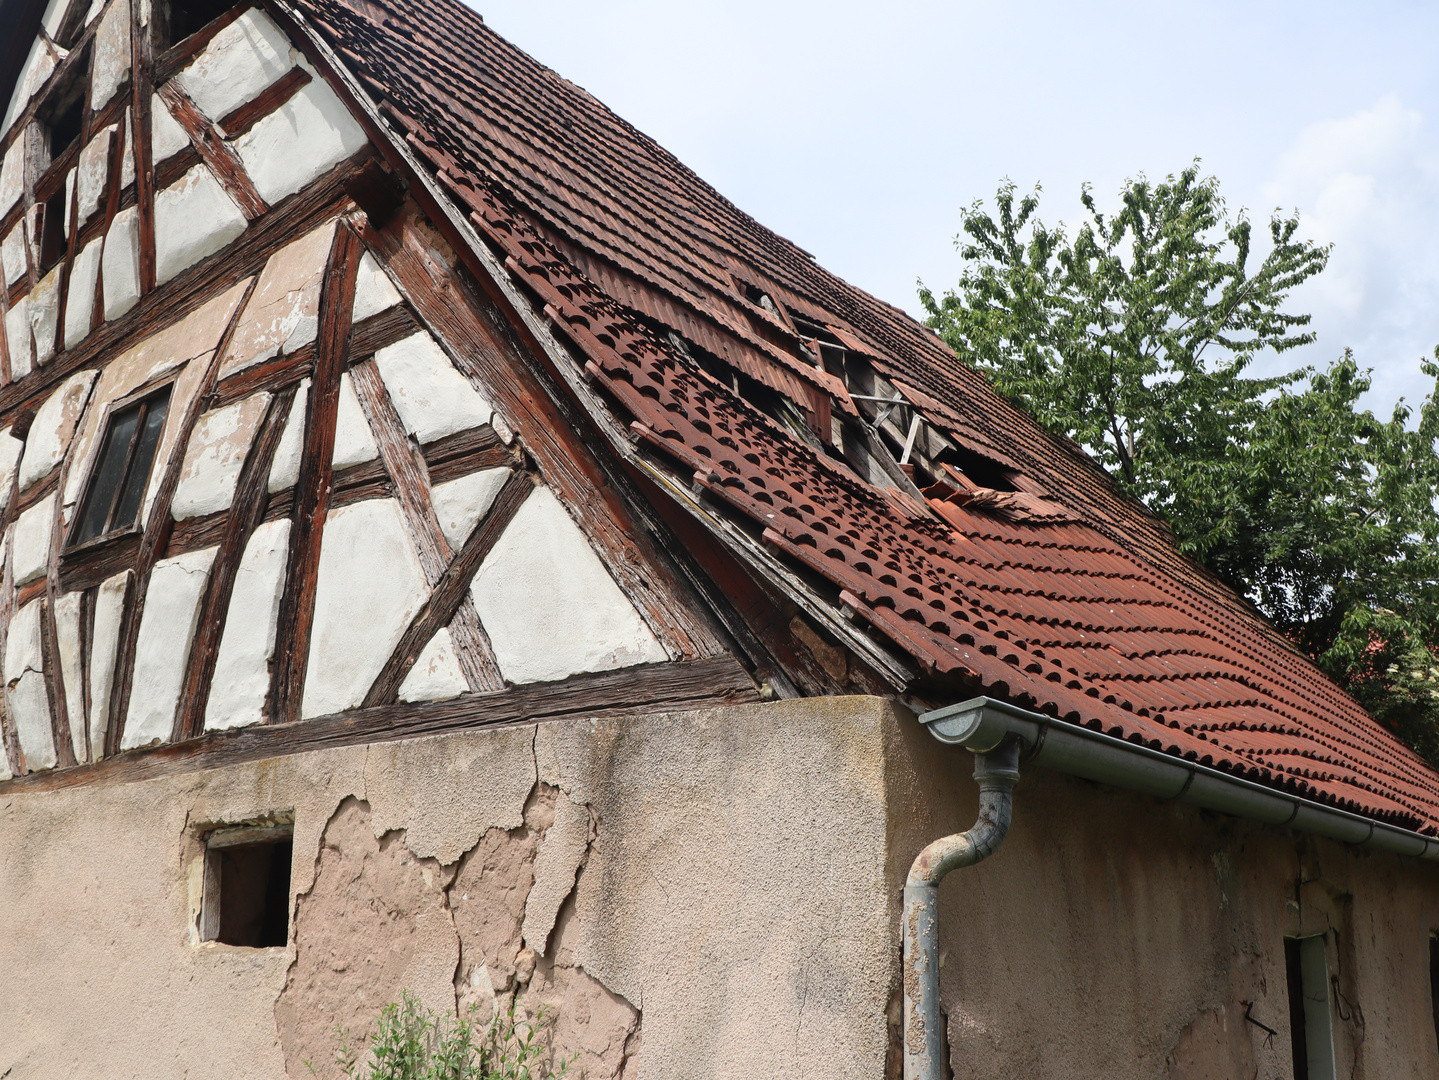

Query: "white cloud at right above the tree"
(1262, 93), (1439, 411)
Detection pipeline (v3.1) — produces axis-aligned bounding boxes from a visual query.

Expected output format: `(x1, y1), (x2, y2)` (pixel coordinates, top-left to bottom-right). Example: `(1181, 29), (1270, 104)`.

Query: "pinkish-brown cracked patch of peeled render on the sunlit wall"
(275, 782), (640, 1080)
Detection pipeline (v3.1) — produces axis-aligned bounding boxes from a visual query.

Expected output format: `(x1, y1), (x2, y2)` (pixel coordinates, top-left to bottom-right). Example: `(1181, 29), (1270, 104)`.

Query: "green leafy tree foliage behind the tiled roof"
(920, 163), (1439, 762)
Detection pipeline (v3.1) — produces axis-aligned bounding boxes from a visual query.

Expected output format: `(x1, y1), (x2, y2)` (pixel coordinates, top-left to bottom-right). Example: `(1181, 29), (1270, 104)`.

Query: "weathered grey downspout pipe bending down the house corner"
(901, 739), (1020, 1080)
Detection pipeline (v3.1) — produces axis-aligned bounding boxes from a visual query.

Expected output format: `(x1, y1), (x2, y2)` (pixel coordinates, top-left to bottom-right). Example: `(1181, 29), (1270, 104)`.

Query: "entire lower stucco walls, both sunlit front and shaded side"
(0, 699), (1439, 1080)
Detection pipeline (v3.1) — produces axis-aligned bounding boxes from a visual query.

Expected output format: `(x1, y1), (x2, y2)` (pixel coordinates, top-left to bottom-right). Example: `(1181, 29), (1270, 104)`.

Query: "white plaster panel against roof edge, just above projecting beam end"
(235, 79), (366, 206)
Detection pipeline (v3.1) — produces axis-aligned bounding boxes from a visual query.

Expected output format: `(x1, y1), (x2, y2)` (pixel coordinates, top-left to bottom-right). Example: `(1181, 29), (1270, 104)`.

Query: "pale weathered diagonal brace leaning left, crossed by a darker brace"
(350, 360), (505, 690)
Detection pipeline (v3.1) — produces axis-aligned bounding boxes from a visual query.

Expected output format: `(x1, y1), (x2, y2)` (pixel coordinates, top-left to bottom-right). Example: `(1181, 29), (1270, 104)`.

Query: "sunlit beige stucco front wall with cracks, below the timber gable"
(0, 699), (894, 1080)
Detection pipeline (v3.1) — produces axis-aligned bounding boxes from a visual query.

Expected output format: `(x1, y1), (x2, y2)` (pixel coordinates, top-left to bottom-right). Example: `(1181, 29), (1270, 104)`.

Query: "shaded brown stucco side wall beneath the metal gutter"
(891, 713), (1439, 1080)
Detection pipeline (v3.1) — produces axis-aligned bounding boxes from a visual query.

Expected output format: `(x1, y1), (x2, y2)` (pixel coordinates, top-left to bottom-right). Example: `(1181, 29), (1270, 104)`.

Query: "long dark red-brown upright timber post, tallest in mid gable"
(268, 221), (364, 723)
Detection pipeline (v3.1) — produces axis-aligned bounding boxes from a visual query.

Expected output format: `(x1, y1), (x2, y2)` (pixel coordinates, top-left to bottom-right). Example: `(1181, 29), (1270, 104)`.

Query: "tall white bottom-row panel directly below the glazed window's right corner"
(121, 548), (217, 751)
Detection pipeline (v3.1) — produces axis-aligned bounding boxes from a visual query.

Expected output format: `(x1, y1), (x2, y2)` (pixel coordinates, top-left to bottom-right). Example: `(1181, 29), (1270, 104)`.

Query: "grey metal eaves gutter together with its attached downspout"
(901, 697), (1439, 1080)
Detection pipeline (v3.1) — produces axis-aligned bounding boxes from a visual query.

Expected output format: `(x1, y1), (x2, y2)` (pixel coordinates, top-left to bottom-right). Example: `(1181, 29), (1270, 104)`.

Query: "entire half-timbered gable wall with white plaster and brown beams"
(0, 0), (696, 779)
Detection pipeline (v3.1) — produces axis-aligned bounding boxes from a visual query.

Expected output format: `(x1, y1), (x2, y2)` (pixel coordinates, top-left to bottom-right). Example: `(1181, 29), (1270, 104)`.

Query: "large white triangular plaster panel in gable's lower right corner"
(471, 488), (669, 683)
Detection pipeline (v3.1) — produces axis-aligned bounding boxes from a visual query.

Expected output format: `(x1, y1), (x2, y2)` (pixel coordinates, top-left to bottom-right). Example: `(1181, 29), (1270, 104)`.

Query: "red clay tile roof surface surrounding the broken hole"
(296, 0), (1439, 831)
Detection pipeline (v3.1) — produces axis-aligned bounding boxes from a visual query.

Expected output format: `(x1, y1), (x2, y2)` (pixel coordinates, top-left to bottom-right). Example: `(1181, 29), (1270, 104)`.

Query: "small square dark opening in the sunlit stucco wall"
(200, 825), (294, 949)
